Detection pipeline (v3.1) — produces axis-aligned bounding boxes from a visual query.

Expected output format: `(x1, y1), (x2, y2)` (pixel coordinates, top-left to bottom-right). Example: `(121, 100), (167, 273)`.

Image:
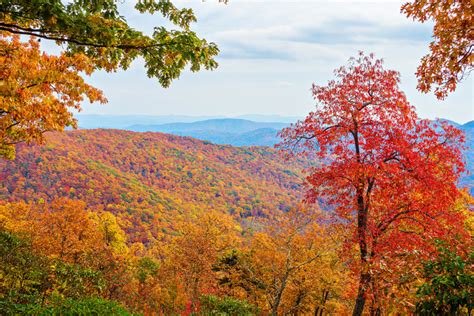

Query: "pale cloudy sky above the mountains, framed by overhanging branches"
(77, 0), (474, 123)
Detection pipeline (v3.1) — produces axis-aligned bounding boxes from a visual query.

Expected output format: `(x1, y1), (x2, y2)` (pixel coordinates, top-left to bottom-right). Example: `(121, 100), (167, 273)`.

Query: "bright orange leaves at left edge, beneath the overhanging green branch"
(0, 32), (106, 159)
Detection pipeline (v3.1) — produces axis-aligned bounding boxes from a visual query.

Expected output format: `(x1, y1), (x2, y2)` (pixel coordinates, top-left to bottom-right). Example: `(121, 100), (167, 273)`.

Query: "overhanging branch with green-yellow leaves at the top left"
(0, 0), (222, 86)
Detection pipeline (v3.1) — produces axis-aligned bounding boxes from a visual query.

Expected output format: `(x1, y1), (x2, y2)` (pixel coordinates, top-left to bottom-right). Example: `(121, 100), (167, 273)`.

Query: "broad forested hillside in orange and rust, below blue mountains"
(0, 130), (304, 241)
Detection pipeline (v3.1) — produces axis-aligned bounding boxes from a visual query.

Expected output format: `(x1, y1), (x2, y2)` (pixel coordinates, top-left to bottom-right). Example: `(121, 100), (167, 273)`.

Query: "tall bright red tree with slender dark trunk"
(280, 53), (463, 315)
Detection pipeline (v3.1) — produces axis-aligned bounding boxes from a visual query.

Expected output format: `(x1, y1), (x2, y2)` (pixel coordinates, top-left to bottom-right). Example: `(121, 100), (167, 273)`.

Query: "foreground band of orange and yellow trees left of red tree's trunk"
(0, 198), (352, 315)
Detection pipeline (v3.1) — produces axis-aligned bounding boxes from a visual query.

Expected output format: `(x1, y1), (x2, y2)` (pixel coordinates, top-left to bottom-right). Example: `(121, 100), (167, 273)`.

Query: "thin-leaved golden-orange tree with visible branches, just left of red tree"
(251, 208), (346, 315)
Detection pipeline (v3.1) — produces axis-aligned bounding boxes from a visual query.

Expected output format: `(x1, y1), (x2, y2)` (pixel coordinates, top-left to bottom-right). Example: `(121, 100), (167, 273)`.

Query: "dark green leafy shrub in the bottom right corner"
(416, 241), (474, 315)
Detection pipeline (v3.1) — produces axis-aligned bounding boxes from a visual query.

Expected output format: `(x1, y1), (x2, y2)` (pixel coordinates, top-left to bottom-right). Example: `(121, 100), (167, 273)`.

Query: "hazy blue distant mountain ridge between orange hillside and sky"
(127, 119), (289, 146)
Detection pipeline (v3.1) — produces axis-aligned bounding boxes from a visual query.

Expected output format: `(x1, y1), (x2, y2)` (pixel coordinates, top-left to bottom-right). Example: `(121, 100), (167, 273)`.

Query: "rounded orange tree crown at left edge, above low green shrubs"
(0, 198), (106, 266)
